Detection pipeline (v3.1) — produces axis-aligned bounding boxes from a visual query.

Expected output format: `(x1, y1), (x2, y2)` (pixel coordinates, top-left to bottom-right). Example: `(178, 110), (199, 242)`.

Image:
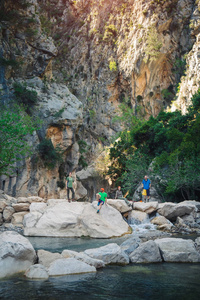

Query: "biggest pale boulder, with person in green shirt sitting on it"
(24, 200), (129, 238)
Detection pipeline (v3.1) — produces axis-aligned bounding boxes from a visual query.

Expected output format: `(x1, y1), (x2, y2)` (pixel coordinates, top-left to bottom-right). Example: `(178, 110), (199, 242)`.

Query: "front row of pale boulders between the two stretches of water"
(0, 231), (200, 280)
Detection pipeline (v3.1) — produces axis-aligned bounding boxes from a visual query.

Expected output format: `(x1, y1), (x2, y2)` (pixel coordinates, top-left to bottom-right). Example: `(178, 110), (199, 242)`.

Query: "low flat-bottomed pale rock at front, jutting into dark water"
(48, 258), (96, 276)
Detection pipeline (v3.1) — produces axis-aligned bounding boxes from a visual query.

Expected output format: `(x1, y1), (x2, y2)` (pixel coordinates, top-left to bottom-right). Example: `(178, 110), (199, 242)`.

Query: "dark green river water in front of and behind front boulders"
(0, 225), (200, 300)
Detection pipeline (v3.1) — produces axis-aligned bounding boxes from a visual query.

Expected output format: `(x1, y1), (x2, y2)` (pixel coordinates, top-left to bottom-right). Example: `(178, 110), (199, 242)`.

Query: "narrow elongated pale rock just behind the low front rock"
(62, 250), (105, 269)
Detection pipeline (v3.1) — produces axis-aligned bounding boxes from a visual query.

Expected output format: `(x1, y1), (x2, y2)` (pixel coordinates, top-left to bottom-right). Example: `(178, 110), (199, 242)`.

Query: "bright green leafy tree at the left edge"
(0, 106), (36, 175)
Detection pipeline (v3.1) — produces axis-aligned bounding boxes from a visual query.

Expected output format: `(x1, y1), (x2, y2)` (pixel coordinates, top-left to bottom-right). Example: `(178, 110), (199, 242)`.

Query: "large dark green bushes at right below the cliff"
(109, 90), (200, 201)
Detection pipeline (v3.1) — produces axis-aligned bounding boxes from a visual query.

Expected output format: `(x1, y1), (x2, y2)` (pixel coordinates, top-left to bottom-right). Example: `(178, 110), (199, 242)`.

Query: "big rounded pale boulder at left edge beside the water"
(0, 231), (36, 278)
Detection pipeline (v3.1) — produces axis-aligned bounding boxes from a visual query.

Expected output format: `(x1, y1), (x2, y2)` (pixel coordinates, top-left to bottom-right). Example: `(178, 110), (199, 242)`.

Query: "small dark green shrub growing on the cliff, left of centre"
(37, 138), (62, 169)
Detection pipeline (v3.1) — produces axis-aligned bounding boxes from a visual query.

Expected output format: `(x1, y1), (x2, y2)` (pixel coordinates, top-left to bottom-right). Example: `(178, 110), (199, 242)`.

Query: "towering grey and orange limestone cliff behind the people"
(0, 0), (200, 198)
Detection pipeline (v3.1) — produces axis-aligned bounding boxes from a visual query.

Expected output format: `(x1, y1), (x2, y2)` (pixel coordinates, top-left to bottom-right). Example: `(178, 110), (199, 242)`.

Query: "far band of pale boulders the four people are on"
(0, 191), (200, 238)
